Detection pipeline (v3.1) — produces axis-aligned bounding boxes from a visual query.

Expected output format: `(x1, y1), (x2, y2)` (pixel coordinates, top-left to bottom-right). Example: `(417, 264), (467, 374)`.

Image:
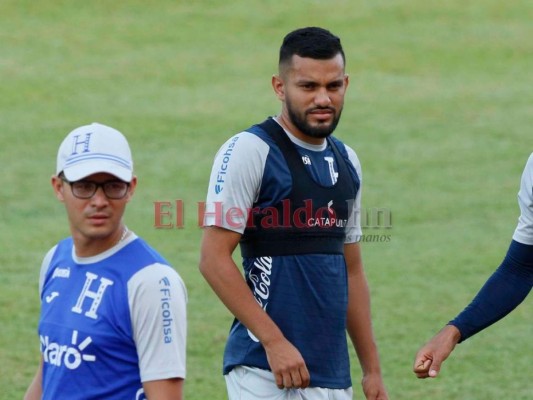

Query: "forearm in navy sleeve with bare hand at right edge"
(413, 240), (533, 378)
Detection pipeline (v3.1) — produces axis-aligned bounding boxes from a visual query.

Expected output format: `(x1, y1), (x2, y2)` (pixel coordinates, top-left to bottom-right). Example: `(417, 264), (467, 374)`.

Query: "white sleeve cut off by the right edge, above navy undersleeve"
(513, 153), (533, 245)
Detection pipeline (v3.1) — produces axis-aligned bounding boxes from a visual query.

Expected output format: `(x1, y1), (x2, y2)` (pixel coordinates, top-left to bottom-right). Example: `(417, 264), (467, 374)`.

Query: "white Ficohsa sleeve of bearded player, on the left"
(203, 132), (270, 233)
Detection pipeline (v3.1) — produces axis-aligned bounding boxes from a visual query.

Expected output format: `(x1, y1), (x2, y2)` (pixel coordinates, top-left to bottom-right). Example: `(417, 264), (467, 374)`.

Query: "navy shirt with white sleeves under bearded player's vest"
(204, 118), (362, 389)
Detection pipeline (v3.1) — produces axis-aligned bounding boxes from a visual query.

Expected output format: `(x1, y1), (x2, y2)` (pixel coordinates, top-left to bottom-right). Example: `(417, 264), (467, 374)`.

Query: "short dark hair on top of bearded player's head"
(279, 27), (346, 65)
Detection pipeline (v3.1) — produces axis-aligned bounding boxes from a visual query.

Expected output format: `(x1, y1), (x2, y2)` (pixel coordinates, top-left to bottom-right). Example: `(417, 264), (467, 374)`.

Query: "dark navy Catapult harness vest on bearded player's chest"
(240, 118), (359, 257)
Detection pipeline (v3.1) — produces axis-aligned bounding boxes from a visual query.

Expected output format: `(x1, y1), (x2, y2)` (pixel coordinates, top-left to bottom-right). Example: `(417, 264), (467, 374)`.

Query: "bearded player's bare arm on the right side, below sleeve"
(344, 243), (389, 400)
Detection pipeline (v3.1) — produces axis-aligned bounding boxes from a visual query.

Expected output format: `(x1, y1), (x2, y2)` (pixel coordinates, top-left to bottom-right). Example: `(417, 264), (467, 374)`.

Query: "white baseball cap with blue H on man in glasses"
(56, 122), (133, 182)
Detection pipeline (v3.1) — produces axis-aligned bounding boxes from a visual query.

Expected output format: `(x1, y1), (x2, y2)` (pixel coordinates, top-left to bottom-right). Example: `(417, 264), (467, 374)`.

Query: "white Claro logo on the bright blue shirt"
(40, 330), (96, 370)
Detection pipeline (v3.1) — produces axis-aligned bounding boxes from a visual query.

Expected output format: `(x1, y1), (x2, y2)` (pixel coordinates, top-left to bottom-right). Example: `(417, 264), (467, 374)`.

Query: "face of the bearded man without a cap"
(273, 54), (348, 142)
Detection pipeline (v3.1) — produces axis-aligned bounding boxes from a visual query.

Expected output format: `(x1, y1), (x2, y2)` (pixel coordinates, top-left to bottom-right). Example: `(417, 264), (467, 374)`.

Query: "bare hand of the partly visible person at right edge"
(413, 325), (461, 379)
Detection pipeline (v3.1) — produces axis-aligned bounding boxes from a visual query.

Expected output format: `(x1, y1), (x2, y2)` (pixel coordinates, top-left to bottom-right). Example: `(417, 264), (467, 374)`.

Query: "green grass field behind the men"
(0, 0), (533, 400)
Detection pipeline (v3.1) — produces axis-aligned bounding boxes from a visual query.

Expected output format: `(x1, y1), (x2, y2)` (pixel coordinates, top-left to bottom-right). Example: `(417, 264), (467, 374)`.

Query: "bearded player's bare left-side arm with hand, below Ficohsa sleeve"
(200, 226), (310, 388)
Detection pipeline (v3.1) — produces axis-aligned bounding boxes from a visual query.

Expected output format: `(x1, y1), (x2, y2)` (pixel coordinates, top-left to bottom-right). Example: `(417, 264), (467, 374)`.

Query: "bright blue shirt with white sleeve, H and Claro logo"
(39, 233), (187, 400)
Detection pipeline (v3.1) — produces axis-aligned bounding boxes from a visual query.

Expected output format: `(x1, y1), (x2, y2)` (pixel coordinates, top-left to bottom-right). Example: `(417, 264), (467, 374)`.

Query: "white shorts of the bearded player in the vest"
(224, 366), (353, 400)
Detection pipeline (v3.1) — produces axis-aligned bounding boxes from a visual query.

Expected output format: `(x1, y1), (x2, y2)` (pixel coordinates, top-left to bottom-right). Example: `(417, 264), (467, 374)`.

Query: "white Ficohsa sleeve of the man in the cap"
(128, 264), (187, 382)
